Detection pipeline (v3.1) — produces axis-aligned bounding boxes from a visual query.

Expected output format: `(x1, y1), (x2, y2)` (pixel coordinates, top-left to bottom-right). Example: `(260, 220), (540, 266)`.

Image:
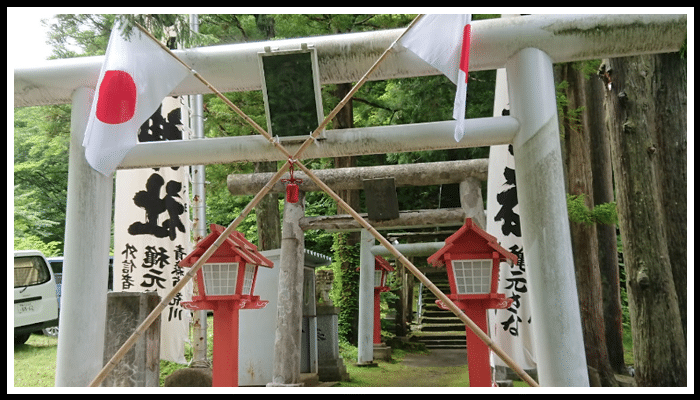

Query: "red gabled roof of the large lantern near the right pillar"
(428, 218), (518, 267)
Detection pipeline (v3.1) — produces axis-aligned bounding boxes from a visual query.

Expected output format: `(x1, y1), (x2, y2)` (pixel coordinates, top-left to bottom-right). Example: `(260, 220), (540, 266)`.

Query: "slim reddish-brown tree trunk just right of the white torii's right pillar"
(560, 63), (618, 386)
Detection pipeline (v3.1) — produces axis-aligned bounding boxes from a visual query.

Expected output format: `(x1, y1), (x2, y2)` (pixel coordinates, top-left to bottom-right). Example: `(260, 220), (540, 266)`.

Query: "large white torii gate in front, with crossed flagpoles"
(14, 15), (686, 386)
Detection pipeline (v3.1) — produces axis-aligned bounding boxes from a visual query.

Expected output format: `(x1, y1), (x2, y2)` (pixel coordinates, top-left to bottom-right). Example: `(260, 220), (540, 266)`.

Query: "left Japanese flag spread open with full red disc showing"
(83, 22), (189, 176)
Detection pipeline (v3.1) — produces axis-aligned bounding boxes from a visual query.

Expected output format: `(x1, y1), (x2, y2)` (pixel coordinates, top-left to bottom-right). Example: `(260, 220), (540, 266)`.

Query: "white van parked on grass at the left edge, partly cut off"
(15, 250), (58, 344)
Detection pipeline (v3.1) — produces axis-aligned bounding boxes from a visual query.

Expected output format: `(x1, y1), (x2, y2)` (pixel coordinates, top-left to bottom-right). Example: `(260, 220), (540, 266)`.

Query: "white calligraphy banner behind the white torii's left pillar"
(113, 97), (192, 364)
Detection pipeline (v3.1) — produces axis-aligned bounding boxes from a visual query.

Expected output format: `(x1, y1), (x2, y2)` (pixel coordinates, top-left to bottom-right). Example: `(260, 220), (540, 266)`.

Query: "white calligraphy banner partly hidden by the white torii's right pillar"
(486, 69), (537, 371)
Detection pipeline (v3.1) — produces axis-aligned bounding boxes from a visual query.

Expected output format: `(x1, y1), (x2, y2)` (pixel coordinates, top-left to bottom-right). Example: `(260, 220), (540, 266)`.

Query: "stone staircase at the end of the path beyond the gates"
(412, 268), (467, 349)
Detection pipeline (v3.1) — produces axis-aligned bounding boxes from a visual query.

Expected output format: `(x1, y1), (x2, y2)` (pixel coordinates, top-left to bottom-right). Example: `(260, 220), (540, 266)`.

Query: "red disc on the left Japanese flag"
(95, 70), (136, 125)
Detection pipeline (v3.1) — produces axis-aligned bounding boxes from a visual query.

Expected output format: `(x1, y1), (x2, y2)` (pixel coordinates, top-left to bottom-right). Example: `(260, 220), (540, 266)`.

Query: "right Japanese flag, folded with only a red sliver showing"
(399, 14), (472, 142)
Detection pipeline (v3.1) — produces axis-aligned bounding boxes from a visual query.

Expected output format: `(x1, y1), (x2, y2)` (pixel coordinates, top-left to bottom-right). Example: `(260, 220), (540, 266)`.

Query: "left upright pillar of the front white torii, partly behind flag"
(55, 87), (114, 387)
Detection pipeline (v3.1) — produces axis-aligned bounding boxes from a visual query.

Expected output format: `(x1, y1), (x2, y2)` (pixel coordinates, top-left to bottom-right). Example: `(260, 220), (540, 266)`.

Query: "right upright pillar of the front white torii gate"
(506, 48), (589, 387)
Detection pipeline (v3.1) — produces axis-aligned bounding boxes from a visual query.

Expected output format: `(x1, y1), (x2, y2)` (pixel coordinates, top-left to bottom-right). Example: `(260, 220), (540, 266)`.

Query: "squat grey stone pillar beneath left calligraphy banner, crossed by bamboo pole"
(101, 292), (160, 387)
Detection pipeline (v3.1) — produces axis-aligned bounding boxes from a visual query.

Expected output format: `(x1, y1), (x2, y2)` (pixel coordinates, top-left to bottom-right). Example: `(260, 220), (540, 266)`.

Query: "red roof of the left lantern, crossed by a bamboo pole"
(179, 224), (274, 268)
